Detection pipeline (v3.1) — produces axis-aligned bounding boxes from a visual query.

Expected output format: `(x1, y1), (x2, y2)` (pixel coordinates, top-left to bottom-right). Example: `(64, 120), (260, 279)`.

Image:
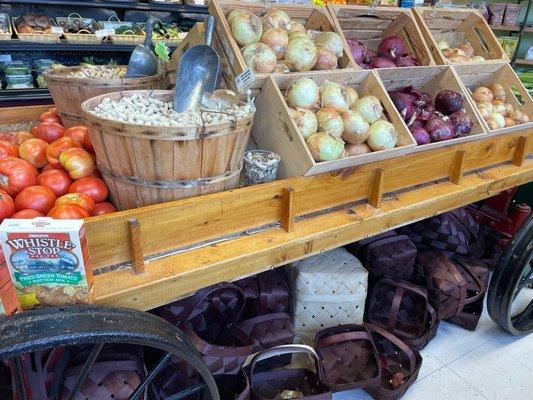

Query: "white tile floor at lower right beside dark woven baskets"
(333, 290), (533, 400)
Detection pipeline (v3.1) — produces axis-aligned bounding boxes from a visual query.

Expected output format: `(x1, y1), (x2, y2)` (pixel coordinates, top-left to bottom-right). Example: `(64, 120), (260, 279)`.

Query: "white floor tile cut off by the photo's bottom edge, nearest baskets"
(402, 367), (485, 400)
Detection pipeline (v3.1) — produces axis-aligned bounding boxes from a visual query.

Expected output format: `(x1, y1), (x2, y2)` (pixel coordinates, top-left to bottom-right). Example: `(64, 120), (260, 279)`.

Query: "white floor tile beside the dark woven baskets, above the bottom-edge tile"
(420, 321), (487, 365)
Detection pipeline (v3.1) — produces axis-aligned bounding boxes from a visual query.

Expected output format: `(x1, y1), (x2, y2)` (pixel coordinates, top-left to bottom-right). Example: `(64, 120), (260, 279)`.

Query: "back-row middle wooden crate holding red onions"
(328, 4), (435, 65)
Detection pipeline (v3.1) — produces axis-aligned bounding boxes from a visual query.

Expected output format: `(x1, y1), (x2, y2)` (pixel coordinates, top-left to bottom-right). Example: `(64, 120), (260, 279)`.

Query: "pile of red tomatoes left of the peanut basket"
(0, 107), (116, 222)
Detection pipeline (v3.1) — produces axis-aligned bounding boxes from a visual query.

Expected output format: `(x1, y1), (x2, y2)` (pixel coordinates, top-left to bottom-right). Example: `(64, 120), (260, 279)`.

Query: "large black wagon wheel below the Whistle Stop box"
(0, 306), (220, 400)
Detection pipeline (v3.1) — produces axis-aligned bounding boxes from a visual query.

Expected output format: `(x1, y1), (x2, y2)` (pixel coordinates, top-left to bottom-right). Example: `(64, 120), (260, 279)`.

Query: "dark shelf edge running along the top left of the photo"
(1, 0), (209, 14)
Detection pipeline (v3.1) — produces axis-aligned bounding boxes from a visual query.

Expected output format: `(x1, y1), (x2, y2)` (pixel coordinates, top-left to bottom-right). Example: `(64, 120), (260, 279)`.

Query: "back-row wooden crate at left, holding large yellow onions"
(209, 0), (360, 90)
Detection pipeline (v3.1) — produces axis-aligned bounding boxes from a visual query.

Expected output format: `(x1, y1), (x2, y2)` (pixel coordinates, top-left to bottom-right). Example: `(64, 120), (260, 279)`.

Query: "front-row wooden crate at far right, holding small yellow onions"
(453, 63), (533, 135)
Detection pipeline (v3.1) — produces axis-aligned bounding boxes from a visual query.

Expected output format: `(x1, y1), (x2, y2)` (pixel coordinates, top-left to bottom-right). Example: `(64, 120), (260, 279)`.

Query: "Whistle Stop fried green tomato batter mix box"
(0, 218), (93, 309)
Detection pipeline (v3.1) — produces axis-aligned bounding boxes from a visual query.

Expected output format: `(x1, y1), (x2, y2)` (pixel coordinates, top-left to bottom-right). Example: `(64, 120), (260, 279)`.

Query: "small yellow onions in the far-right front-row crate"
(472, 83), (529, 130)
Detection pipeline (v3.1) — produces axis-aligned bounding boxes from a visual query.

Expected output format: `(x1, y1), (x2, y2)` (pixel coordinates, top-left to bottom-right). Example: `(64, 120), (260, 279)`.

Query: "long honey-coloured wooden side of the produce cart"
(0, 106), (533, 310)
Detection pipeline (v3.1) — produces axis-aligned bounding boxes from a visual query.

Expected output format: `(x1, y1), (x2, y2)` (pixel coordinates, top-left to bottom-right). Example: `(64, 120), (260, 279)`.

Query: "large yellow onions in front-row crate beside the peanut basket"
(285, 78), (398, 162)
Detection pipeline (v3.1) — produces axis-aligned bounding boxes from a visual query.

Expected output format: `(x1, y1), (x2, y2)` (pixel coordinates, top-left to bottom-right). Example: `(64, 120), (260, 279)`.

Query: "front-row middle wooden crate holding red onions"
(376, 65), (485, 151)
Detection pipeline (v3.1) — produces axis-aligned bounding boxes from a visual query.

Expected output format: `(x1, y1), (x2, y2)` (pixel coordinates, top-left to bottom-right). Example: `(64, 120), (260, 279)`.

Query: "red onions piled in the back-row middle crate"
(346, 36), (420, 69)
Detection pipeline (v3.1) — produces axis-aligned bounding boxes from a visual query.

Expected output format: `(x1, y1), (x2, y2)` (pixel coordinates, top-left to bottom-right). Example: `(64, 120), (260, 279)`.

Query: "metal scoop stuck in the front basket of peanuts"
(174, 15), (220, 112)
